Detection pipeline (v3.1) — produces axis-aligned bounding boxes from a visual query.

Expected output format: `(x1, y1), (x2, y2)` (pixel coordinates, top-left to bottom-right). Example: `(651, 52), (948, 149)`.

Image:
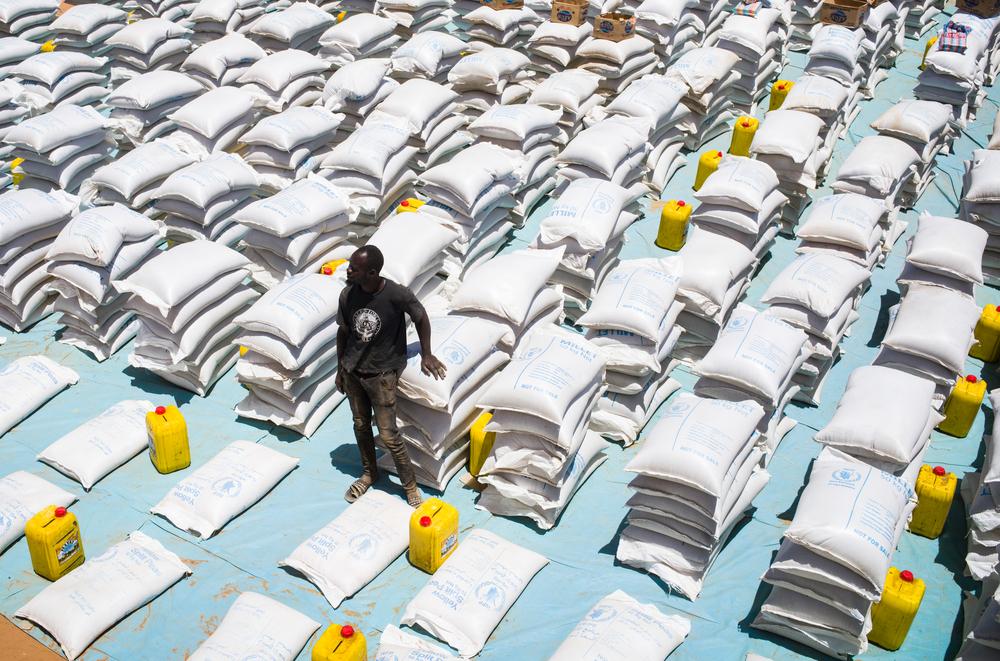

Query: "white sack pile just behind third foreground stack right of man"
(685, 304), (809, 454)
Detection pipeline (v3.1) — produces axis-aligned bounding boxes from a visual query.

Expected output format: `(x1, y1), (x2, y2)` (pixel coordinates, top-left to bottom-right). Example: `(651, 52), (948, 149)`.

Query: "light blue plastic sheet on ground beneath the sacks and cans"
(0, 10), (1000, 661)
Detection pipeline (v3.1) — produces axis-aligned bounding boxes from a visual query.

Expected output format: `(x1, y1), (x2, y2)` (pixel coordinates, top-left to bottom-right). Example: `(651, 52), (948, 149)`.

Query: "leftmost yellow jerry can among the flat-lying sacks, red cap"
(24, 505), (84, 581)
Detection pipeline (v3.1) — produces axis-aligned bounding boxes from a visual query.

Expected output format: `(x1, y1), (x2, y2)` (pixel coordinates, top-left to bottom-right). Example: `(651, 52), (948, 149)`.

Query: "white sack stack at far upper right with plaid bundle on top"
(913, 11), (1000, 125)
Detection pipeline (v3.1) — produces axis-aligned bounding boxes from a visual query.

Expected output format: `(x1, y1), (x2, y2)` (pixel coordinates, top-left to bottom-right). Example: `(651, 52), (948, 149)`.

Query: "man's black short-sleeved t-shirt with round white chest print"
(337, 278), (425, 374)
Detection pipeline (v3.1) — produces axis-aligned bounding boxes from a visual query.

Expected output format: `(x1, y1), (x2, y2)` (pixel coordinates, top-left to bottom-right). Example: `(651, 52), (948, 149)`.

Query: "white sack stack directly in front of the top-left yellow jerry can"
(11, 51), (110, 113)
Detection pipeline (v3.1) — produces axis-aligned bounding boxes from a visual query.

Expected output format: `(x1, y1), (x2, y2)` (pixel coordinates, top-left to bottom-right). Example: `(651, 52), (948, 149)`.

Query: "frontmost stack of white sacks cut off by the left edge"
(0, 189), (79, 333)
